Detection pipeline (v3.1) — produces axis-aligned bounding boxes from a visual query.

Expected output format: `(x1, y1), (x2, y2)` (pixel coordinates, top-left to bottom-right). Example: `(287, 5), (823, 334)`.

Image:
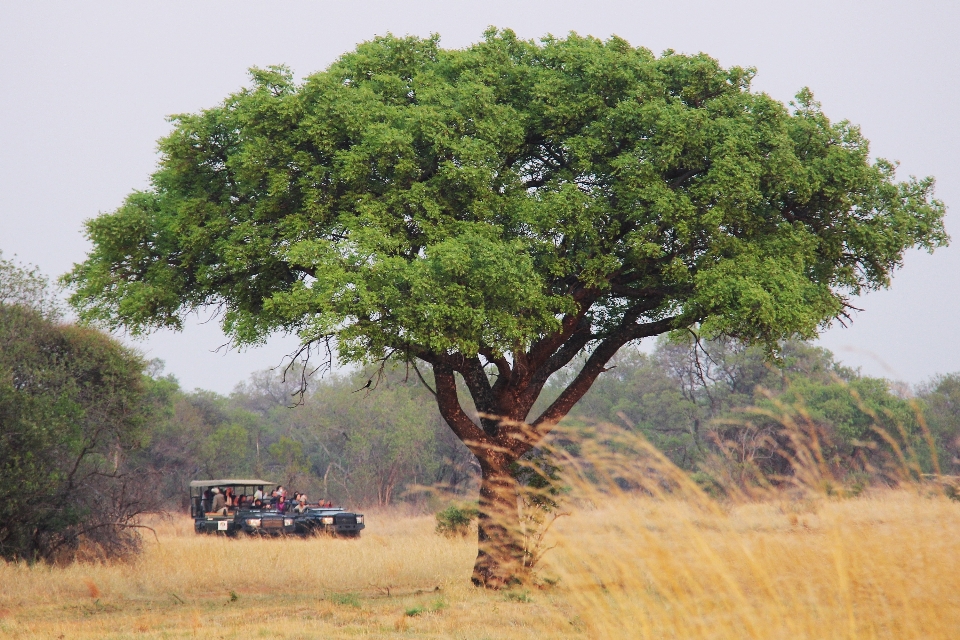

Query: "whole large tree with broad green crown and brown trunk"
(66, 30), (947, 586)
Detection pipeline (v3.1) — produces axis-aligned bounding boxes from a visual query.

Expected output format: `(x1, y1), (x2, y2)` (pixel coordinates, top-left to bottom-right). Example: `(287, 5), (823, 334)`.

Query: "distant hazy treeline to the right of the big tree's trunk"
(548, 336), (936, 482)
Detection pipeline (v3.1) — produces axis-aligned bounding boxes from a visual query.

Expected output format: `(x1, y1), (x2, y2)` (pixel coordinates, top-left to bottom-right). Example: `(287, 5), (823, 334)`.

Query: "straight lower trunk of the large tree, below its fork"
(472, 462), (525, 589)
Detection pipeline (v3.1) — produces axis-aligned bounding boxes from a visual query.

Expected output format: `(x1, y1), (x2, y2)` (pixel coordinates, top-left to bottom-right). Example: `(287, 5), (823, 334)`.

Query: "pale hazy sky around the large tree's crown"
(0, 0), (960, 392)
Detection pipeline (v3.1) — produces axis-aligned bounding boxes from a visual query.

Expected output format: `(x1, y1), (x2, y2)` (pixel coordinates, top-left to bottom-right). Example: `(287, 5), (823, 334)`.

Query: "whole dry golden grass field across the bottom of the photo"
(0, 488), (960, 639)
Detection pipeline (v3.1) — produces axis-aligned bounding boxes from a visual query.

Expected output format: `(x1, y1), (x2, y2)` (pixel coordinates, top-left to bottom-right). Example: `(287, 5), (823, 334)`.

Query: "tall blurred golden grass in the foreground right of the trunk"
(547, 490), (960, 639)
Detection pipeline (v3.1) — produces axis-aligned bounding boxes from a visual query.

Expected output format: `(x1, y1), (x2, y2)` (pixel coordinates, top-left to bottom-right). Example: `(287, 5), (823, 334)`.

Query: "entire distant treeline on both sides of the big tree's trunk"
(141, 338), (960, 505)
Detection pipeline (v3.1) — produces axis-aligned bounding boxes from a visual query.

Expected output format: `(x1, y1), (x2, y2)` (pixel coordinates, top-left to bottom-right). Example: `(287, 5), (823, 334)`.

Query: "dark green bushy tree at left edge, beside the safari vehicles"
(0, 255), (155, 561)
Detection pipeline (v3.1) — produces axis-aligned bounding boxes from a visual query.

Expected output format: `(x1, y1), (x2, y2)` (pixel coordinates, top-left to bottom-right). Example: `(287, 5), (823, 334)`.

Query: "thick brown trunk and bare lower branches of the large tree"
(420, 316), (675, 589)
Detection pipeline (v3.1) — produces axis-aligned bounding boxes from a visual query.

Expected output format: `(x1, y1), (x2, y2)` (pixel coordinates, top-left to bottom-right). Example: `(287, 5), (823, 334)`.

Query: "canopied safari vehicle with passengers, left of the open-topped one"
(190, 478), (297, 536)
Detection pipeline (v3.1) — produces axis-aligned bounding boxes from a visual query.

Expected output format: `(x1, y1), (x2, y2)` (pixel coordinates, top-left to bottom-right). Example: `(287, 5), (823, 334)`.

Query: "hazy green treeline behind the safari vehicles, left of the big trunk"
(140, 369), (477, 505)
